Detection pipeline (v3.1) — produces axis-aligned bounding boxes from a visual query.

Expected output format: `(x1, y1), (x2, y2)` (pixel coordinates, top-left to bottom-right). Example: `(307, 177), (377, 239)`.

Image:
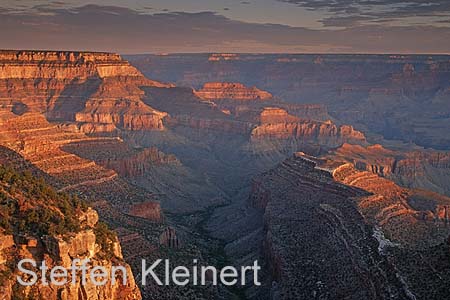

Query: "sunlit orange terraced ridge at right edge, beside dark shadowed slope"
(333, 158), (450, 247)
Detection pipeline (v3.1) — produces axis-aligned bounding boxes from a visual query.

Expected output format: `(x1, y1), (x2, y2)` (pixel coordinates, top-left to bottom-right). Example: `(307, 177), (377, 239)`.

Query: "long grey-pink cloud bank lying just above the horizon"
(0, 5), (450, 53)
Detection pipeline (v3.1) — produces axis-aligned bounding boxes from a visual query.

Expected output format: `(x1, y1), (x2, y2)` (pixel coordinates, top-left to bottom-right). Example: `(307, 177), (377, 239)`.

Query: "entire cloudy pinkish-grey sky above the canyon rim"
(0, 0), (450, 54)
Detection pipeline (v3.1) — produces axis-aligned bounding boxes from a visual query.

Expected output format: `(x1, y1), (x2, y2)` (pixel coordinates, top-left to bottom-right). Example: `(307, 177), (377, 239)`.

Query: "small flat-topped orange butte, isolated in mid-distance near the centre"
(195, 82), (272, 100)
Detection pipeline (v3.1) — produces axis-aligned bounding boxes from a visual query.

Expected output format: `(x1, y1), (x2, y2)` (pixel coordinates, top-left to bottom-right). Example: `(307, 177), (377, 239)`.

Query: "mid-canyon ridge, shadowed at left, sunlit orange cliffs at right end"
(144, 86), (366, 151)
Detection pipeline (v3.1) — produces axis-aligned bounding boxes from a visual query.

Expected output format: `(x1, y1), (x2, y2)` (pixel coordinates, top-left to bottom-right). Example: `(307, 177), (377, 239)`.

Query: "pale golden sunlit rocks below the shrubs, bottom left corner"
(0, 231), (141, 300)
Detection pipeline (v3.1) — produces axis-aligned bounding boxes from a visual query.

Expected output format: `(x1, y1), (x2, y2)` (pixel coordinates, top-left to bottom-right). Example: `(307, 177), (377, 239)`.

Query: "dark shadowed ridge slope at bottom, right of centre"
(249, 157), (408, 299)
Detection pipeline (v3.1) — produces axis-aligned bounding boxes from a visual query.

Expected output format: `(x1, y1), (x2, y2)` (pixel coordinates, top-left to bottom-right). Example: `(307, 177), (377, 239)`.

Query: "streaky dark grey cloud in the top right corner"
(277, 0), (450, 27)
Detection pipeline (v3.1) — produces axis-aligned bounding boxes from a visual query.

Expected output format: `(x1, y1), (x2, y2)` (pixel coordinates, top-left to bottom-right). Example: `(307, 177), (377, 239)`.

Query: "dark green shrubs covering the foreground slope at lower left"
(0, 166), (87, 235)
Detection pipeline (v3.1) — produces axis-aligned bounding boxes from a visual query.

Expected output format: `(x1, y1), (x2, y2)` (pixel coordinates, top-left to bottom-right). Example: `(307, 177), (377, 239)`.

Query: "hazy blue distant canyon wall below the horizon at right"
(127, 54), (450, 150)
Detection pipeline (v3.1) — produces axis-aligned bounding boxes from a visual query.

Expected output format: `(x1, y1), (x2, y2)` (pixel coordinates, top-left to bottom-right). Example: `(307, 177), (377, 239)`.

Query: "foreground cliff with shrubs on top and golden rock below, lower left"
(0, 162), (141, 300)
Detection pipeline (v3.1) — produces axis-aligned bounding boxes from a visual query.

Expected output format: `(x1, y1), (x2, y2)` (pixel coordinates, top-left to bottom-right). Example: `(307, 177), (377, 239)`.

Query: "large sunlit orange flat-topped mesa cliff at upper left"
(0, 51), (170, 133)
